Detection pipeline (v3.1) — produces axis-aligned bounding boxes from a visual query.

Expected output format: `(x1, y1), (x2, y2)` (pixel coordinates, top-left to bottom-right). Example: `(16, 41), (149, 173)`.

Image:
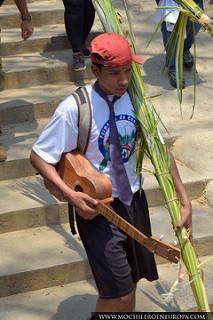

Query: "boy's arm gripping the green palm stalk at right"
(171, 155), (192, 230)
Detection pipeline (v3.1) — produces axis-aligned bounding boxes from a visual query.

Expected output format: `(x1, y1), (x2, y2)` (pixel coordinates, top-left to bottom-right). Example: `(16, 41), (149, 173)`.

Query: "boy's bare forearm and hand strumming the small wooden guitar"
(30, 150), (98, 219)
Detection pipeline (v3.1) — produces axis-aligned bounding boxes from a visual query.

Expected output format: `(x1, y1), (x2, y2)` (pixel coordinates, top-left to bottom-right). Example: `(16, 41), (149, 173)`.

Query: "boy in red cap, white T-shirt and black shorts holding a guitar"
(31, 33), (191, 312)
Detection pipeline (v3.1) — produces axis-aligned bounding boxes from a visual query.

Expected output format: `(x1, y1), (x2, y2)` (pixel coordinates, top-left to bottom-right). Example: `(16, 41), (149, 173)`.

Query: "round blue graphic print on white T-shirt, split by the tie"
(98, 114), (137, 171)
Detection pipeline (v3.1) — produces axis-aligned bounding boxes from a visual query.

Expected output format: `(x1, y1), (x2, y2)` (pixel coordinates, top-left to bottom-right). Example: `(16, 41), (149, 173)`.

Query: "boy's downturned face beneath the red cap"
(92, 63), (131, 96)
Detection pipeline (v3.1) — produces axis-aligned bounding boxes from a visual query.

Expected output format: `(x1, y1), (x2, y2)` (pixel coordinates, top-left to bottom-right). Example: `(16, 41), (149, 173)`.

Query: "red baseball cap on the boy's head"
(91, 32), (143, 67)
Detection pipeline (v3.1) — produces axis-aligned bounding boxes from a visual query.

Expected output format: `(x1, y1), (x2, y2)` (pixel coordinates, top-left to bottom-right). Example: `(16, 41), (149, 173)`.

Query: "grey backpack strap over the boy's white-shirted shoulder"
(73, 87), (92, 154)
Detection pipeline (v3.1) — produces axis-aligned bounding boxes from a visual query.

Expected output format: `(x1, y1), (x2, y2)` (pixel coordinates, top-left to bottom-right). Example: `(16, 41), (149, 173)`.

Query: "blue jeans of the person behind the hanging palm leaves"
(156, 0), (203, 71)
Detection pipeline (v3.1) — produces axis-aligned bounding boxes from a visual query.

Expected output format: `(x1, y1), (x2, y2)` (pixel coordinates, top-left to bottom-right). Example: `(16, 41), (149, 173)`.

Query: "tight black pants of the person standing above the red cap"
(63, 0), (95, 52)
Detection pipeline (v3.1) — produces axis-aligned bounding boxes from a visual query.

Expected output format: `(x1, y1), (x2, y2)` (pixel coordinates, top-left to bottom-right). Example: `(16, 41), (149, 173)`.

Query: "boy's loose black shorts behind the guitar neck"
(76, 190), (158, 299)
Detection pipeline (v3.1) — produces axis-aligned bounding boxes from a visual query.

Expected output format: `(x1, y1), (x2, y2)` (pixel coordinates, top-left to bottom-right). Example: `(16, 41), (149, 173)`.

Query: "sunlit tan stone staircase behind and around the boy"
(0, 0), (213, 320)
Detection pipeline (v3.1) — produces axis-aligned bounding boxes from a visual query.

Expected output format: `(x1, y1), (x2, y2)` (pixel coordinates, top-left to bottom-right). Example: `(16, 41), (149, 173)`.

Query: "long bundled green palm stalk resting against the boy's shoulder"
(93, 0), (210, 312)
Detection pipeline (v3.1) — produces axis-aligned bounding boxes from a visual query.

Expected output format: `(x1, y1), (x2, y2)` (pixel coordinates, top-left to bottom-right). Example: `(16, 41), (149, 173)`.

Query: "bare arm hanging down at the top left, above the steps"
(14, 0), (33, 40)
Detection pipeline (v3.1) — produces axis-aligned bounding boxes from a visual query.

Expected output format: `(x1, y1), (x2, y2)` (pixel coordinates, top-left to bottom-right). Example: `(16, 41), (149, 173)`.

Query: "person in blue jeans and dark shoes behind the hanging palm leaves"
(155, 0), (203, 88)
